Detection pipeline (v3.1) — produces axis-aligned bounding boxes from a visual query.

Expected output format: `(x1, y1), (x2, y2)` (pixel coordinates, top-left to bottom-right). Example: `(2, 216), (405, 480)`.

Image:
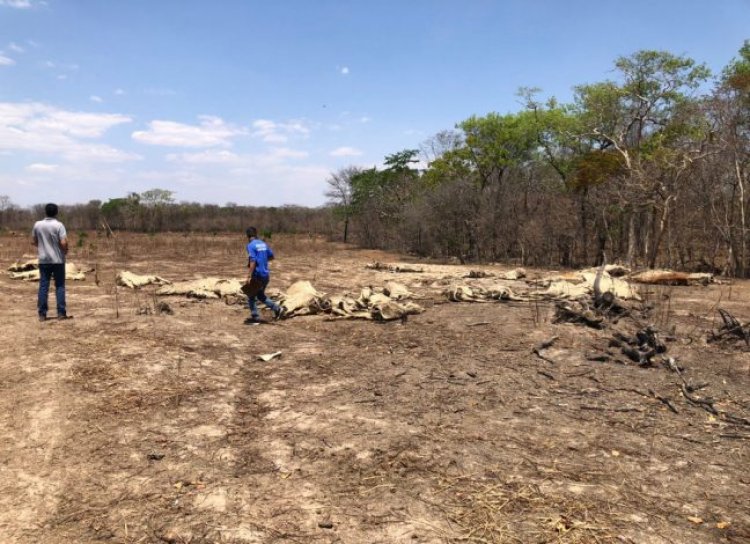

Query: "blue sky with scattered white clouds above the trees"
(0, 0), (750, 206)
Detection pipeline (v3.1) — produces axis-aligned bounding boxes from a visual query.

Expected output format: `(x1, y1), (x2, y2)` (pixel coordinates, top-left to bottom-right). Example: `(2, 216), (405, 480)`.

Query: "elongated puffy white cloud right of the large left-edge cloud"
(132, 115), (246, 147)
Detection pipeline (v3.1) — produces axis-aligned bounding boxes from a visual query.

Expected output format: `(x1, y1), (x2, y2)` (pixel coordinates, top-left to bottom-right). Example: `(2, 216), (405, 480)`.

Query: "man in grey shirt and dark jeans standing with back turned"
(31, 204), (68, 321)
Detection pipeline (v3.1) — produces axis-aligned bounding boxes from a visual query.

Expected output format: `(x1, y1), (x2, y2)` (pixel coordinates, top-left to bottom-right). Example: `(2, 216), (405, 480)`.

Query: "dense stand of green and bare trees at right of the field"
(326, 41), (750, 276)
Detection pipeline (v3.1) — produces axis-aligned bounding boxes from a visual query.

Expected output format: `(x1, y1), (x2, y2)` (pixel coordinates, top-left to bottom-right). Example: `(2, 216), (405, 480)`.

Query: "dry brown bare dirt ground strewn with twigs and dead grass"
(0, 234), (750, 544)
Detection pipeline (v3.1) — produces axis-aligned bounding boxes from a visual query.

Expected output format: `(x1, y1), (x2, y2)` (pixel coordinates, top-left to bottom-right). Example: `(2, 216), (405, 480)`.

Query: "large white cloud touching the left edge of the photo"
(0, 102), (139, 162)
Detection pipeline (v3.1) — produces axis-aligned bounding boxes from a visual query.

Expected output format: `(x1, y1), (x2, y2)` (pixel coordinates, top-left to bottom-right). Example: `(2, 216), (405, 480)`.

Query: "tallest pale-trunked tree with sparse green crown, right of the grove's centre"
(576, 51), (710, 266)
